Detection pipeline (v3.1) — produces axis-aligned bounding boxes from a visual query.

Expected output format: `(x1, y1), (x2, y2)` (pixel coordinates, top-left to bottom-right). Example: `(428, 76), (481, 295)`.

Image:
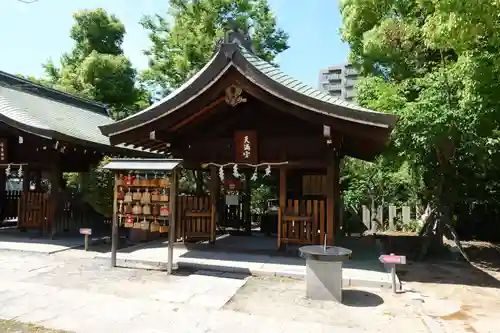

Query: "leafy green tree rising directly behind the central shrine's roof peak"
(141, 0), (288, 95)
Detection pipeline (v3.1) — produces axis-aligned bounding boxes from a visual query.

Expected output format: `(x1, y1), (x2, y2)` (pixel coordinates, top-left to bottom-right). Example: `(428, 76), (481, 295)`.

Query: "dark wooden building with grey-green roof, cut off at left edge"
(0, 72), (158, 235)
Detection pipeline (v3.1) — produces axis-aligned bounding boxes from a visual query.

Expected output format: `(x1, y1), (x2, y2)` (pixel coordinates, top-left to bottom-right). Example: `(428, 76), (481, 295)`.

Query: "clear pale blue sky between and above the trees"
(0, 0), (348, 87)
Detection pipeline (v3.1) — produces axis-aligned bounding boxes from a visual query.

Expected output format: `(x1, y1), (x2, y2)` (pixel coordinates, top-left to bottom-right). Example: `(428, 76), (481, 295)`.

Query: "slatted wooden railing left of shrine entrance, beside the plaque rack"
(176, 195), (215, 240)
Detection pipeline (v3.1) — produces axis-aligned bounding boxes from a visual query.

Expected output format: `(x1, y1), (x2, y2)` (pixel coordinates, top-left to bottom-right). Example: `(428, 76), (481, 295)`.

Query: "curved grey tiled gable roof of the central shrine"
(100, 32), (397, 160)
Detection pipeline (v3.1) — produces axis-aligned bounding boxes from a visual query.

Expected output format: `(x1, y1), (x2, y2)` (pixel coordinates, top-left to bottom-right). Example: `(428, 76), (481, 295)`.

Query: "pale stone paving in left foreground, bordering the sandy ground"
(0, 250), (402, 333)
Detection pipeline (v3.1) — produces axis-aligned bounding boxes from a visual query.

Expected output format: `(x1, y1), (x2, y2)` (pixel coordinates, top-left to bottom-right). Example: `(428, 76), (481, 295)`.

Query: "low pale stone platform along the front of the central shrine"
(96, 241), (399, 288)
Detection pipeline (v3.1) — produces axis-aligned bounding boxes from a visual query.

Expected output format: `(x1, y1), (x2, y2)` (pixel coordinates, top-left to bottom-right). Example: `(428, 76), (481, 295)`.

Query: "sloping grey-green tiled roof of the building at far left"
(0, 71), (158, 154)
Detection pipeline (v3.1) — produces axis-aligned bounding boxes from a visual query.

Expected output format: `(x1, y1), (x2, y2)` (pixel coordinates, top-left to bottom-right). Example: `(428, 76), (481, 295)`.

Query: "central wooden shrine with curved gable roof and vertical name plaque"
(100, 32), (396, 247)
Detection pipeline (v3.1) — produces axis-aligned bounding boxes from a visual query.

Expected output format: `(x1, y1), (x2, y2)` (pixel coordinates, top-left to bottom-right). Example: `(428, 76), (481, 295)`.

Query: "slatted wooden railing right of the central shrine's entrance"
(278, 199), (326, 246)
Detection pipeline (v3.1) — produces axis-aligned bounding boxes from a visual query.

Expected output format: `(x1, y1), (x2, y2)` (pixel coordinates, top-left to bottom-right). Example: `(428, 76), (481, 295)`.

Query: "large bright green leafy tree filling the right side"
(341, 0), (500, 231)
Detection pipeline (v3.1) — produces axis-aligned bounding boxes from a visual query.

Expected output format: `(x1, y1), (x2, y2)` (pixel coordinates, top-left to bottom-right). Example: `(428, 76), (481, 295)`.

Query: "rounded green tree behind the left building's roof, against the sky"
(44, 9), (150, 119)
